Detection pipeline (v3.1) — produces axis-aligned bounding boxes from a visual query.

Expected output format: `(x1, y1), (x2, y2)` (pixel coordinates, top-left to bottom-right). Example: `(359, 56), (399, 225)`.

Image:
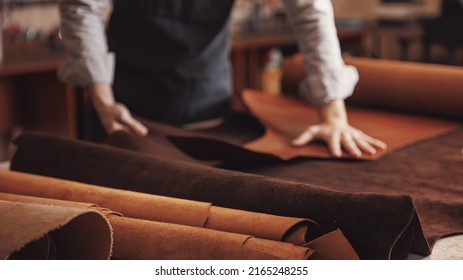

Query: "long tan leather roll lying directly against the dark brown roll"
(0, 168), (323, 245)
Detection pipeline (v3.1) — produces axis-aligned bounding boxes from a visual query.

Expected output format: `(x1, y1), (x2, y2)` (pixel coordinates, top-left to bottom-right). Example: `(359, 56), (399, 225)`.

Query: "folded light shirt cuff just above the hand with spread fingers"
(299, 65), (359, 106)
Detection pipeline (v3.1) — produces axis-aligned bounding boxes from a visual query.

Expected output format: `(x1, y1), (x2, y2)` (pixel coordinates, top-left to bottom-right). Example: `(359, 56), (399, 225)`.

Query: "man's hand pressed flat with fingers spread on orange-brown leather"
(293, 100), (387, 158)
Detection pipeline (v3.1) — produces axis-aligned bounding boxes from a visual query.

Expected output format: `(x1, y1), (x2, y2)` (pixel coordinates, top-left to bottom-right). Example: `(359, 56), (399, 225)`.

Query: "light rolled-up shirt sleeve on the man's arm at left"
(58, 0), (114, 86)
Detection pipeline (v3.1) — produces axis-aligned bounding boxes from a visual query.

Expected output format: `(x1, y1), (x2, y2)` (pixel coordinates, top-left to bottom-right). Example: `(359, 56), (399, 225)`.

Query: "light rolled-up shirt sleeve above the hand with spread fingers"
(284, 0), (358, 106)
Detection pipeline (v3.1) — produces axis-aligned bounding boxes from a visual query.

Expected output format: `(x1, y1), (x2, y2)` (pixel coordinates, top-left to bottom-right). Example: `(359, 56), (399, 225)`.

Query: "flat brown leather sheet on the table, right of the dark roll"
(240, 128), (463, 253)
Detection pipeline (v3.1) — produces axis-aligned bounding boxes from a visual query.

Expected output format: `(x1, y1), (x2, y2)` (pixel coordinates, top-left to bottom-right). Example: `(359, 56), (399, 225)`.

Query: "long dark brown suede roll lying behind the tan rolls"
(12, 134), (430, 259)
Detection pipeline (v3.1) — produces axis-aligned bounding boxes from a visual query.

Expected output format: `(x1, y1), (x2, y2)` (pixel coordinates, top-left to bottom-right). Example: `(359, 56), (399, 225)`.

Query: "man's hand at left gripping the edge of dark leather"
(90, 84), (148, 136)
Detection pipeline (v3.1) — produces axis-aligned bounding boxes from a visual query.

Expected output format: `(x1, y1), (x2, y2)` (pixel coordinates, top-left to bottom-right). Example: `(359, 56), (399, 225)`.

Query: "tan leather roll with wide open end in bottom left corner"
(0, 194), (112, 259)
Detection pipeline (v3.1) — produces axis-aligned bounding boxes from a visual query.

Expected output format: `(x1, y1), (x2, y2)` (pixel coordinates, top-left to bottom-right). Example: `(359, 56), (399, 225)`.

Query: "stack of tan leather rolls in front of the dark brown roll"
(0, 171), (357, 260)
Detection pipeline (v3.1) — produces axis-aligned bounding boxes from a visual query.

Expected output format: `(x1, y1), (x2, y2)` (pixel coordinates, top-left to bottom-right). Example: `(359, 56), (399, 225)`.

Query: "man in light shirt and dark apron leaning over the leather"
(59, 0), (385, 157)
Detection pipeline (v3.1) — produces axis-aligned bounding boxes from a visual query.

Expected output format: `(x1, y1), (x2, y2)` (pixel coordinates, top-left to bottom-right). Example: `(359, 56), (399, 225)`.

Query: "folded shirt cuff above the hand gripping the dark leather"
(58, 53), (115, 87)
